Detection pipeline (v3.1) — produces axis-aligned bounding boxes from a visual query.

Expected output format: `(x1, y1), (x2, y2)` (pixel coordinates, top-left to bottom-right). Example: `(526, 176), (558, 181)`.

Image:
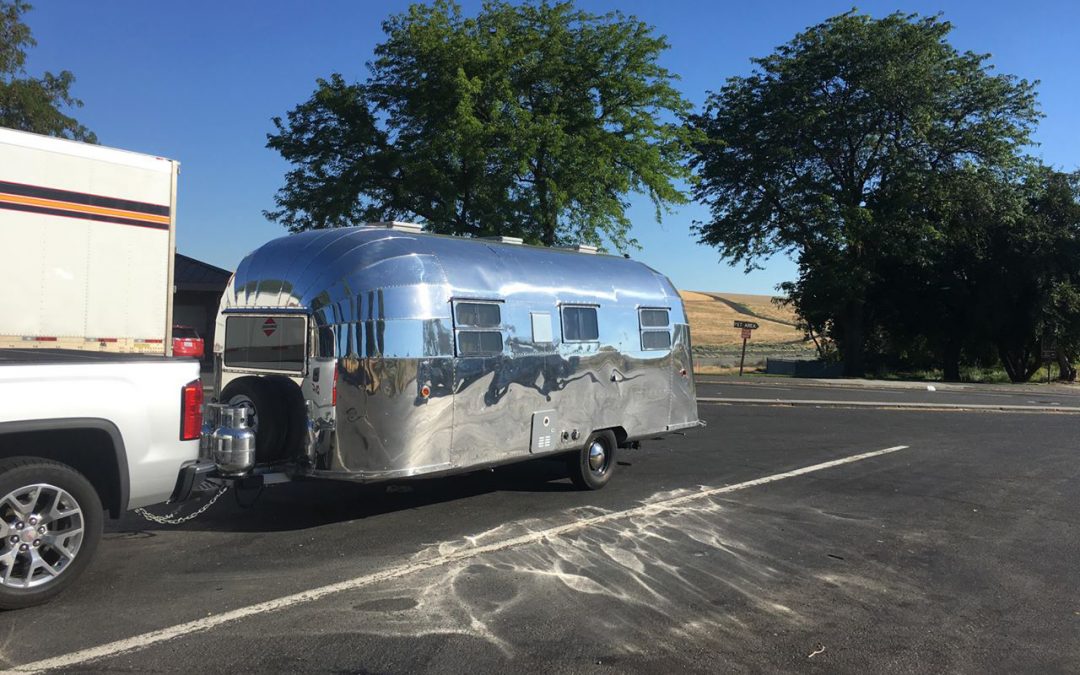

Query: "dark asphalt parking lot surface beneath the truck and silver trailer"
(0, 377), (1080, 673)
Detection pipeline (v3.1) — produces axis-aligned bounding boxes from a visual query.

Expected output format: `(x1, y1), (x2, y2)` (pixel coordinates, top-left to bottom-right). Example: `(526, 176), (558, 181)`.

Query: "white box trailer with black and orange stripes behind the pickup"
(0, 129), (179, 355)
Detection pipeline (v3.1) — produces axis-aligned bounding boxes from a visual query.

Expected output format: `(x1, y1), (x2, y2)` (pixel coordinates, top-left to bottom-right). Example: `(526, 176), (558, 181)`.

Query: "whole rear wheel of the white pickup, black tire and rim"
(0, 457), (105, 609)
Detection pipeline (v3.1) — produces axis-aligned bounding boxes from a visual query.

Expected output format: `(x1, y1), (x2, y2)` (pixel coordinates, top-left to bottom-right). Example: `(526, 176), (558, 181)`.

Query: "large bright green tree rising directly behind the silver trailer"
(266, 1), (690, 249)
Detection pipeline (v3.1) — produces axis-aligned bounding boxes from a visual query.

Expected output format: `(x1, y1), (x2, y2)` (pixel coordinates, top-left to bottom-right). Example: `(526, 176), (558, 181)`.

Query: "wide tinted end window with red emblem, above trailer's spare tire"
(225, 316), (308, 373)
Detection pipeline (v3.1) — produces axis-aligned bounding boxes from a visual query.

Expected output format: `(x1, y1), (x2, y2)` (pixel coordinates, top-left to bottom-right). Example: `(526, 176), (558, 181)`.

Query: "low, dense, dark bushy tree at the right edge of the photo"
(851, 162), (1080, 382)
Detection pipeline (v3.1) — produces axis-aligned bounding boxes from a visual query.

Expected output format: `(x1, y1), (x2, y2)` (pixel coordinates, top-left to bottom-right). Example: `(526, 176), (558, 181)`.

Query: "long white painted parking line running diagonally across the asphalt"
(6, 445), (908, 673)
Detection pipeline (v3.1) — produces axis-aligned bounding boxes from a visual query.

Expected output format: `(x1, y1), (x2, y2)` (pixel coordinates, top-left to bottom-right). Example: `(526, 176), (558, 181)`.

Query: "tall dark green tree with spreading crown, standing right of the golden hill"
(691, 12), (1038, 375)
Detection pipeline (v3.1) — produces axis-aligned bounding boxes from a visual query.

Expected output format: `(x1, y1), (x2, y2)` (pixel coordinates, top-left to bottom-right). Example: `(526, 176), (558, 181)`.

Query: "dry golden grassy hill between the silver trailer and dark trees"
(679, 291), (802, 346)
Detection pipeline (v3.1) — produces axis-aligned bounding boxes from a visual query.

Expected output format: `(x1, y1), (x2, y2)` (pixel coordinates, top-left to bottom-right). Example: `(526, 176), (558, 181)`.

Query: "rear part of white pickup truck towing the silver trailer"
(0, 349), (205, 609)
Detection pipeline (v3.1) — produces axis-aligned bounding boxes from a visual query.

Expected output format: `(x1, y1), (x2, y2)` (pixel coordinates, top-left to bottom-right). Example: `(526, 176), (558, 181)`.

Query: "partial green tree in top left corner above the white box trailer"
(0, 0), (97, 143)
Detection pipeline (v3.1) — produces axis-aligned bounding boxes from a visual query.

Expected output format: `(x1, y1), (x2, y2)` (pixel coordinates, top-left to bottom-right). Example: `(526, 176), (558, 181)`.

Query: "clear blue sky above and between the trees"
(19, 0), (1080, 293)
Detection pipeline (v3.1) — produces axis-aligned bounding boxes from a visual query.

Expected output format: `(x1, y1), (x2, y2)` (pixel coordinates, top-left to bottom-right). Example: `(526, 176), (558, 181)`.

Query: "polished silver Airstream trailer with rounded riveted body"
(204, 222), (699, 489)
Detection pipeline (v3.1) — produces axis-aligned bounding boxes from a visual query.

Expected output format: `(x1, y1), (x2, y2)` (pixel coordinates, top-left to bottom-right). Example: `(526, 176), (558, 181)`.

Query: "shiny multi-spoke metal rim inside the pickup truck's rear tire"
(0, 483), (85, 589)
